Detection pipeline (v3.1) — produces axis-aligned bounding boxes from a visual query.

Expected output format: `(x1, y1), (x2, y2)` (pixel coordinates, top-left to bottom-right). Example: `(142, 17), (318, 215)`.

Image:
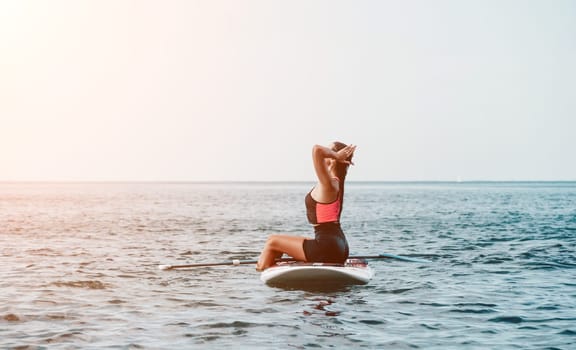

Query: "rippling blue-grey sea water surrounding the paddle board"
(0, 182), (576, 350)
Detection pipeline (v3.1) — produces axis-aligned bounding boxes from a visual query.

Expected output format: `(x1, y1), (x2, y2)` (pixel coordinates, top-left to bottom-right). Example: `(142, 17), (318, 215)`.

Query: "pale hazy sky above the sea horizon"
(0, 0), (576, 181)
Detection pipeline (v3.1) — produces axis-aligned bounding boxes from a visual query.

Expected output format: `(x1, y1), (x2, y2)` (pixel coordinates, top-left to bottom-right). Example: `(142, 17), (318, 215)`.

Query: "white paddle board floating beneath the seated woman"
(260, 259), (374, 286)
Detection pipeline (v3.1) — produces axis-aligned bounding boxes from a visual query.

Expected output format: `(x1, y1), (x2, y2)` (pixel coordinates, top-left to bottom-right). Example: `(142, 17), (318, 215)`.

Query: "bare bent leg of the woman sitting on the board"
(256, 235), (306, 271)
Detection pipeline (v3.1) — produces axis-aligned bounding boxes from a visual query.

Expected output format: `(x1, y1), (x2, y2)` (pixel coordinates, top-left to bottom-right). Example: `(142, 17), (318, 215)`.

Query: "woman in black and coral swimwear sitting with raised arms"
(256, 142), (356, 271)
